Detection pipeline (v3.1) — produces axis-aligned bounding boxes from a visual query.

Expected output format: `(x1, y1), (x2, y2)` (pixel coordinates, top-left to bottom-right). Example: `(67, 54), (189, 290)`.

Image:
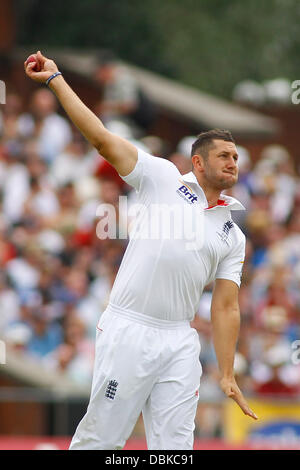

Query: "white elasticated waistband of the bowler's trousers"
(106, 303), (191, 330)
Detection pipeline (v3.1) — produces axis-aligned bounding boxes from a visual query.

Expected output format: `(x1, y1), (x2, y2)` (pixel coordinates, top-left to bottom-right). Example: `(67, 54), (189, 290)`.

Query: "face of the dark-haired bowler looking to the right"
(203, 140), (238, 190)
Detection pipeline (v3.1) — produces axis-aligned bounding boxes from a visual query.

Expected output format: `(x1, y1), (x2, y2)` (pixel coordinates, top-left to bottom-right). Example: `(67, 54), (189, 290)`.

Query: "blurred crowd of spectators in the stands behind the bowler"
(0, 60), (300, 435)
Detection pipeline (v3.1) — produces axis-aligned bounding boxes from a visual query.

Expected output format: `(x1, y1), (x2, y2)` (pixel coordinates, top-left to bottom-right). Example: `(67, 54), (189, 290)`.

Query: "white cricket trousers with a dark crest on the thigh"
(70, 304), (202, 450)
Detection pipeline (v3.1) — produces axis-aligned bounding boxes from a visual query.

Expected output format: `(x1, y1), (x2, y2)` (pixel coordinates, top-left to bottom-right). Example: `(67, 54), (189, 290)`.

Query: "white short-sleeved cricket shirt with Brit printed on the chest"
(110, 150), (245, 321)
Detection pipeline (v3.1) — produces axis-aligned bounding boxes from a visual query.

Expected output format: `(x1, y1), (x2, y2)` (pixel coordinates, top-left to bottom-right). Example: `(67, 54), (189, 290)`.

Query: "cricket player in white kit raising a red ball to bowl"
(25, 51), (257, 450)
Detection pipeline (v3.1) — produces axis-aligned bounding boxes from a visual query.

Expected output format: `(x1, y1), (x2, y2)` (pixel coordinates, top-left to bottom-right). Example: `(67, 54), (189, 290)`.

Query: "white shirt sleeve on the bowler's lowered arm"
(216, 231), (246, 287)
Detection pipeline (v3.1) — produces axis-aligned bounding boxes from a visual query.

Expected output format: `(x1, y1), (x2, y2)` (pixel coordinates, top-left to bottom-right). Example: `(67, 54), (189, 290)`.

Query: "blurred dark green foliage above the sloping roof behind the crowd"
(14, 0), (300, 97)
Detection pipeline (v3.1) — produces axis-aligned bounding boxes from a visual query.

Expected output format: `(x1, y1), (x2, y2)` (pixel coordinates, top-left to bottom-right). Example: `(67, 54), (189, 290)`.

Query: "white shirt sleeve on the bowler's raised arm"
(120, 148), (178, 193)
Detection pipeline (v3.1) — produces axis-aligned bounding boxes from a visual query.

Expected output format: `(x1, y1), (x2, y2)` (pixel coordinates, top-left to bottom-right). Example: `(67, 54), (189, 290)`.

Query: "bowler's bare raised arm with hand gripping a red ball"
(24, 51), (137, 176)
